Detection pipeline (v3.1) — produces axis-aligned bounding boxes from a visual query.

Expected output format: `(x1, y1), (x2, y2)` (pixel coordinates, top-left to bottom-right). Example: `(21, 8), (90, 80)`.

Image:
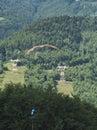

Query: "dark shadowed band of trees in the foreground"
(0, 84), (97, 130)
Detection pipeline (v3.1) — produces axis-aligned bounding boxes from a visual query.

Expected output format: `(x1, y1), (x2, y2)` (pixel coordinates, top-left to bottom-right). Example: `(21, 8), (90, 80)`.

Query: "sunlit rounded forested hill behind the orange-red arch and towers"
(0, 16), (97, 106)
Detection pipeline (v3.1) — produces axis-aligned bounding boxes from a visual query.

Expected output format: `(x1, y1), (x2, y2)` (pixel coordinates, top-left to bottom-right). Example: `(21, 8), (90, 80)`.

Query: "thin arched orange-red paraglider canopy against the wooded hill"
(25, 44), (60, 56)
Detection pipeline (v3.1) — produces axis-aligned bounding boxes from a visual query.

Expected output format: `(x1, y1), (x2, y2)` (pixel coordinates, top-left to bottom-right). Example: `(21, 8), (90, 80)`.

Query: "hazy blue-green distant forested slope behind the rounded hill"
(0, 0), (97, 39)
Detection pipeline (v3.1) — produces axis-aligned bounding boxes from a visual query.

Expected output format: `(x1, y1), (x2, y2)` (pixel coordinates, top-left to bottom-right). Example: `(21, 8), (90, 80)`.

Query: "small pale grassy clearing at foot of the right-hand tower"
(57, 81), (73, 97)
